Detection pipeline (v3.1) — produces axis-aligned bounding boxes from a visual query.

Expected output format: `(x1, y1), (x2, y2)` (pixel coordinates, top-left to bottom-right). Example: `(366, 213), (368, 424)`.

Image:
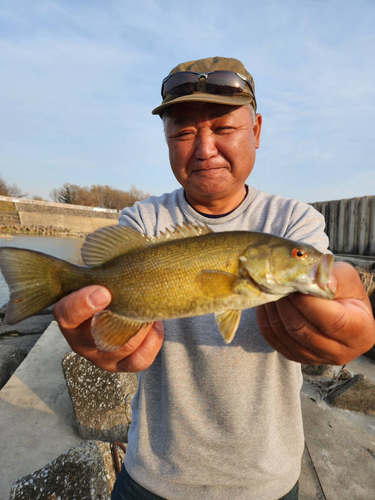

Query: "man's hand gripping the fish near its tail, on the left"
(53, 285), (164, 372)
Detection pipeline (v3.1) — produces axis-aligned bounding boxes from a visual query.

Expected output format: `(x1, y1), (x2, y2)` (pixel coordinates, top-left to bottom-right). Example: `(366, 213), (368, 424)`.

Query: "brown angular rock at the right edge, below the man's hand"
(326, 375), (375, 415)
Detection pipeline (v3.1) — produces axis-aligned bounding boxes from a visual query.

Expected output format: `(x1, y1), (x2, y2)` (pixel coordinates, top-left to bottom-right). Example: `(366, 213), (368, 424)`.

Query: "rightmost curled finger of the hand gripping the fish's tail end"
(117, 321), (164, 372)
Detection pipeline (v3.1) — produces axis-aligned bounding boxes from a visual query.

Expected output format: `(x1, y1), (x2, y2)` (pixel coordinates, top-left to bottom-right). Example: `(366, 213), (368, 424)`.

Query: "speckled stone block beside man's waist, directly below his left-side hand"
(62, 351), (138, 442)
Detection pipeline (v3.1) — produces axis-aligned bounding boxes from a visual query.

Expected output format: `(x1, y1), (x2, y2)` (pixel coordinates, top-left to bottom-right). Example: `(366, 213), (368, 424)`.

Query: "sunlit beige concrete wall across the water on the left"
(0, 196), (120, 233)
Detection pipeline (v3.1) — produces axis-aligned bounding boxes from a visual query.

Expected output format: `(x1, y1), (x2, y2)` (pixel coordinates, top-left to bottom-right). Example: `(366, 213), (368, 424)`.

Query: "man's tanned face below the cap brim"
(164, 103), (262, 206)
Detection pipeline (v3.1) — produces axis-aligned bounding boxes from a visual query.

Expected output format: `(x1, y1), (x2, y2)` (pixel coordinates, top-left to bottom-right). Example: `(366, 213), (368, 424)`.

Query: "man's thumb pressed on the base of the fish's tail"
(53, 285), (111, 330)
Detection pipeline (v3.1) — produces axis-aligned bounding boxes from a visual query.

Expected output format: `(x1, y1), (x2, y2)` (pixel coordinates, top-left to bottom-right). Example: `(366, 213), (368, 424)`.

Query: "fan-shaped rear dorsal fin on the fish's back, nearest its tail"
(81, 226), (153, 266)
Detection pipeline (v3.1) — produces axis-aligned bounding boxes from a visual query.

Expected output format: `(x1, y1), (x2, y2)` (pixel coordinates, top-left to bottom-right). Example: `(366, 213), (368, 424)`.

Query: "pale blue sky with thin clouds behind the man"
(0, 0), (375, 202)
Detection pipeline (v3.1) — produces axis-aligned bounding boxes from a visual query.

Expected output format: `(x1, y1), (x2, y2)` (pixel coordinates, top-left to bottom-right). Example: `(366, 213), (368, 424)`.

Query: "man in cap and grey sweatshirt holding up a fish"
(55, 57), (375, 500)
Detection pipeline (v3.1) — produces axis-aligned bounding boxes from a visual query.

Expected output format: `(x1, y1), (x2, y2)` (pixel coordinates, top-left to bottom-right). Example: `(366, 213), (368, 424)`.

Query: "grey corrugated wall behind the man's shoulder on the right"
(311, 196), (375, 256)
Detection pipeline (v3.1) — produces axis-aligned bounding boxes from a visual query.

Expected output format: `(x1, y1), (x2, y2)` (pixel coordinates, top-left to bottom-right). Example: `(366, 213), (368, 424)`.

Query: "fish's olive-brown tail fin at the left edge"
(0, 247), (71, 325)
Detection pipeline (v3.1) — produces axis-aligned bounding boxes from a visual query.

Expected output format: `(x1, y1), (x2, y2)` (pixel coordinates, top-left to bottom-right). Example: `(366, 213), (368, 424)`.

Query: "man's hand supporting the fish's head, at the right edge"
(257, 262), (375, 365)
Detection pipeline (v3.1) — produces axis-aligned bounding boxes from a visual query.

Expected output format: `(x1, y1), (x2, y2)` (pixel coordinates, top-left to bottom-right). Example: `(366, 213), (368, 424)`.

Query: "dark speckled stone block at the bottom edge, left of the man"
(9, 441), (124, 500)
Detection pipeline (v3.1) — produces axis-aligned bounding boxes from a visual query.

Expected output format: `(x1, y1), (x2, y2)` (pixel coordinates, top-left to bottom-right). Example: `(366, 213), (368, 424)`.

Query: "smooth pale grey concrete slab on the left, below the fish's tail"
(0, 322), (82, 500)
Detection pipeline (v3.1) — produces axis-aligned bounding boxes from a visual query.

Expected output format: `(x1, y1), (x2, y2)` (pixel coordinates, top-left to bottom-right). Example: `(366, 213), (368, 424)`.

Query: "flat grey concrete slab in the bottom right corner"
(301, 381), (375, 500)
